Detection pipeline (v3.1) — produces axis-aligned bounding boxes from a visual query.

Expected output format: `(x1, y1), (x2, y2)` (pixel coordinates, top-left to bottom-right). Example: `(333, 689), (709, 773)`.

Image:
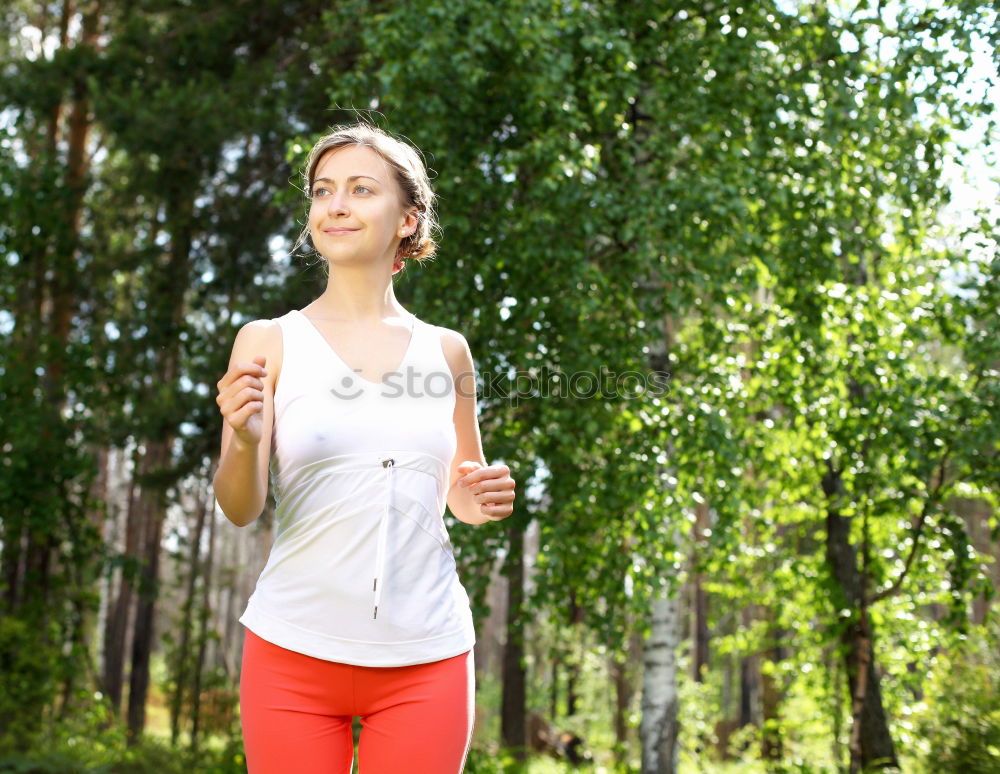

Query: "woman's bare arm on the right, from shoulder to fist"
(441, 328), (515, 524)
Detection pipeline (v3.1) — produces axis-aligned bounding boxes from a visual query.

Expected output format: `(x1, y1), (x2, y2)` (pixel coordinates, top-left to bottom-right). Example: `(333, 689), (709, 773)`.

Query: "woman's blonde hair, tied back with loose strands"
(292, 120), (440, 276)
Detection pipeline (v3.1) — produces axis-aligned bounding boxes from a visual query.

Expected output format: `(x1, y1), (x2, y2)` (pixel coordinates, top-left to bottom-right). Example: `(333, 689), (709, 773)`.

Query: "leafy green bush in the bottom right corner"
(915, 617), (1000, 774)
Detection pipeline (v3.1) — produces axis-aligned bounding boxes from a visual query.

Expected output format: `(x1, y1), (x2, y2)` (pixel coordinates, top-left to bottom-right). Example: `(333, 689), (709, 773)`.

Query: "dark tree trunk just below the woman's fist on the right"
(500, 523), (527, 762)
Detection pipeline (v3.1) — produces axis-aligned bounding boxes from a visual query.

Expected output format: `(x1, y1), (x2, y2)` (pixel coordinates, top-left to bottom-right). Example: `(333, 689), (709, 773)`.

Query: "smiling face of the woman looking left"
(309, 145), (416, 267)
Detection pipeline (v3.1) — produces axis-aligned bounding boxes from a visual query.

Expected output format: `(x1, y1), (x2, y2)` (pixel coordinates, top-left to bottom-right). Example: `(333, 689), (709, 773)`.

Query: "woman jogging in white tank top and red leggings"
(213, 123), (515, 774)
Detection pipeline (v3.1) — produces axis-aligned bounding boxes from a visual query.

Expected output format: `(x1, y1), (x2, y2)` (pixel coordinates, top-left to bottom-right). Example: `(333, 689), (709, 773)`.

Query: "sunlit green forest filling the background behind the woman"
(0, 0), (1000, 774)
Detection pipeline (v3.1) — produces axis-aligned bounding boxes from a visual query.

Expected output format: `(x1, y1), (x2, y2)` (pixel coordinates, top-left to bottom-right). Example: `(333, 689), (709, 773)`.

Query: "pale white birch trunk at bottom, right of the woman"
(639, 591), (681, 774)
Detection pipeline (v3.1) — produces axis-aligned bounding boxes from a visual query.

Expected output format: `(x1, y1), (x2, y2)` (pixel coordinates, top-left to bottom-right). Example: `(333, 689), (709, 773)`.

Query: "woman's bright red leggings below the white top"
(240, 629), (475, 774)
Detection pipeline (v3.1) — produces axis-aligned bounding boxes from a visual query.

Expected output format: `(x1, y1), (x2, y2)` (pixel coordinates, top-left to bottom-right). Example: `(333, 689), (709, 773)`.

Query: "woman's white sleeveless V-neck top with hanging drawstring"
(239, 310), (475, 666)
